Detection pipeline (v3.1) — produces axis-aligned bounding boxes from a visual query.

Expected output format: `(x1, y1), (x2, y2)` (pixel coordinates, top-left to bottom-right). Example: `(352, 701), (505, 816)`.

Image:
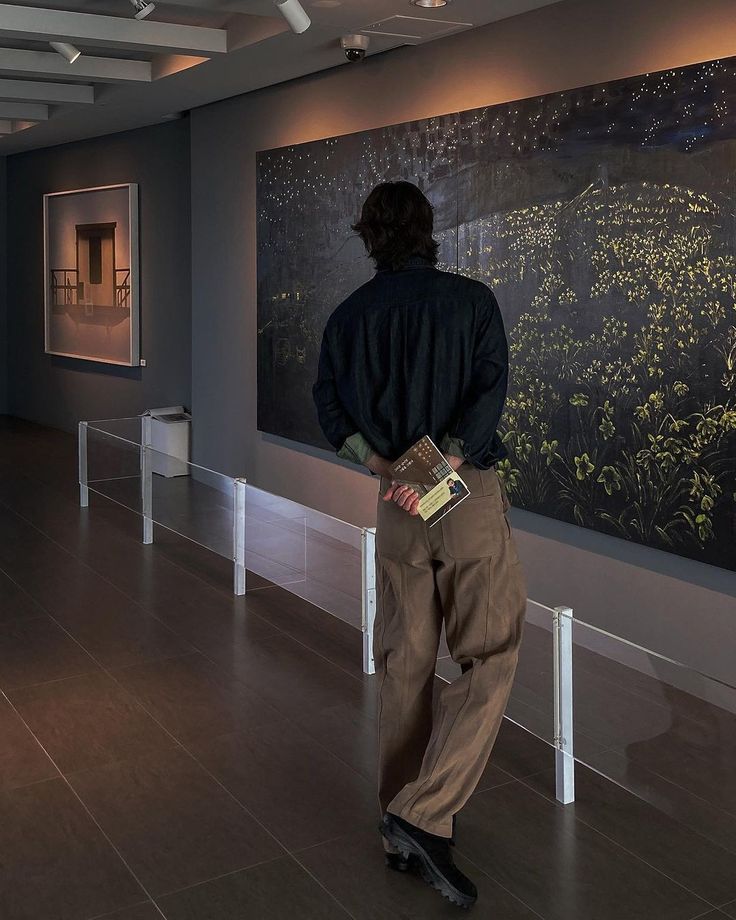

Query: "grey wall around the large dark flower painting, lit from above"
(191, 0), (736, 680)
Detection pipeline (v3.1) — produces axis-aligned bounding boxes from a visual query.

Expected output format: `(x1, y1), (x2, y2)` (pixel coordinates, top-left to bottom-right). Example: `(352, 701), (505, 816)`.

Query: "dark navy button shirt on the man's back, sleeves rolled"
(312, 256), (508, 478)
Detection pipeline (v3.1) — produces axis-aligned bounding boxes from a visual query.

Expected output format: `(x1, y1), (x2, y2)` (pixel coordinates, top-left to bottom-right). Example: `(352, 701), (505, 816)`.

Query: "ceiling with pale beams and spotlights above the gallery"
(0, 0), (559, 155)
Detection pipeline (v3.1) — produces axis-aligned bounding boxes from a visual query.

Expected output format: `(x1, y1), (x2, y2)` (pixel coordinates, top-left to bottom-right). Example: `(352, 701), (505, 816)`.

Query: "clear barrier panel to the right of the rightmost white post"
(556, 620), (736, 832)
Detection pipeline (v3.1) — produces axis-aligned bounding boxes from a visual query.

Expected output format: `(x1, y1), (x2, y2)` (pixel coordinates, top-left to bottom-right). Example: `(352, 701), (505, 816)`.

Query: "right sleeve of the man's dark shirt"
(451, 288), (509, 469)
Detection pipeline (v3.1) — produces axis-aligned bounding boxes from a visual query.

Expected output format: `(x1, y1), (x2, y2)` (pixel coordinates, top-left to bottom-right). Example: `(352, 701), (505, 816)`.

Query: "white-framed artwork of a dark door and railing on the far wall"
(43, 183), (140, 366)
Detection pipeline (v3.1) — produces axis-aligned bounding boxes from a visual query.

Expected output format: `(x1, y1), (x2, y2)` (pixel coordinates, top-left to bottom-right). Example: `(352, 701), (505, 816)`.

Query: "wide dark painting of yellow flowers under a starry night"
(258, 59), (736, 569)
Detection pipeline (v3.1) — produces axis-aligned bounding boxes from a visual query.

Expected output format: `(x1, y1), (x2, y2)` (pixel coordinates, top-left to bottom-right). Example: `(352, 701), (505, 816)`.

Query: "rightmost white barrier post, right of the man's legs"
(553, 607), (575, 805)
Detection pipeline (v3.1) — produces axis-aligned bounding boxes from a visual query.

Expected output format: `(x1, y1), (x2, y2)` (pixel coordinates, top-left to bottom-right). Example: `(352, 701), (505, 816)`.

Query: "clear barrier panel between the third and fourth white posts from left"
(245, 485), (362, 629)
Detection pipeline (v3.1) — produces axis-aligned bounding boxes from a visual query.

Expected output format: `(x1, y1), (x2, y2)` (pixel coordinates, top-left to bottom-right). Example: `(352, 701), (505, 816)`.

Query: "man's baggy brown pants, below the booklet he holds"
(373, 462), (526, 837)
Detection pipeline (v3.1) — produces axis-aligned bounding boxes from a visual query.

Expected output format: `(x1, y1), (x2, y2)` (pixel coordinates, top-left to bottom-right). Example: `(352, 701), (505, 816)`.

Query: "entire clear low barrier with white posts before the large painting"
(79, 416), (736, 812)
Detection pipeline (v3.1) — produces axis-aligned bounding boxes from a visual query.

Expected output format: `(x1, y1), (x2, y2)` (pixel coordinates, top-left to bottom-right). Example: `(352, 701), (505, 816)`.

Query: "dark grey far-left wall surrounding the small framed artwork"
(6, 118), (191, 430)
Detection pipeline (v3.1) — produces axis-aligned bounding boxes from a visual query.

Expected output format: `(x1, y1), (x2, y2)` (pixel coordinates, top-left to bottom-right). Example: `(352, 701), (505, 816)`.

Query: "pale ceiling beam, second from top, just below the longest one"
(0, 48), (152, 83)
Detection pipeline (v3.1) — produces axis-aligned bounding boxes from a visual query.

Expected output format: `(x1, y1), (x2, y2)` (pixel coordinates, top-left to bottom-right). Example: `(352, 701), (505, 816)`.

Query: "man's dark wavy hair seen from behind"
(353, 181), (439, 269)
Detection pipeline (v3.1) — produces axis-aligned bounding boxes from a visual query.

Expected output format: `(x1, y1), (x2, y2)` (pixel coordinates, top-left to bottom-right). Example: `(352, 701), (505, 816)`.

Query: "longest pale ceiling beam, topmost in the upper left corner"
(0, 3), (227, 55)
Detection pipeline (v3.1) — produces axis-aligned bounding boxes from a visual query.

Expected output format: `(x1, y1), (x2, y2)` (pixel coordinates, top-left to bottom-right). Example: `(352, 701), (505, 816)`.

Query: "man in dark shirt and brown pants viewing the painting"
(313, 182), (526, 907)
